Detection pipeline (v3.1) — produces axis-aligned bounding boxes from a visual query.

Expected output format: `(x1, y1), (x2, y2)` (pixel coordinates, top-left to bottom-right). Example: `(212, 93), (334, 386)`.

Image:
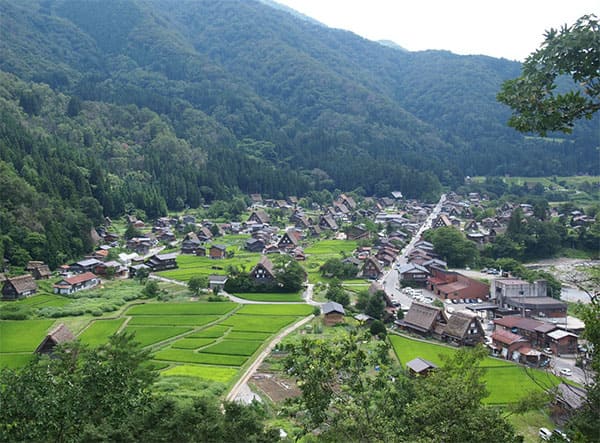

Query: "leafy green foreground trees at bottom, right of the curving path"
(286, 332), (520, 443)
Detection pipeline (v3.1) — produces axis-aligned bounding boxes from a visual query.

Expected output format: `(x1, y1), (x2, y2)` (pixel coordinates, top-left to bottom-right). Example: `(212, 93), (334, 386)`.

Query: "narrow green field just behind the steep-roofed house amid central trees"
(158, 251), (260, 281)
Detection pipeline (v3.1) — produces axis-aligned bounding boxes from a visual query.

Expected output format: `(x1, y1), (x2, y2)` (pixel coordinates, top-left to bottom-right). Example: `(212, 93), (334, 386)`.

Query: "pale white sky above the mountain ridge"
(276, 0), (600, 61)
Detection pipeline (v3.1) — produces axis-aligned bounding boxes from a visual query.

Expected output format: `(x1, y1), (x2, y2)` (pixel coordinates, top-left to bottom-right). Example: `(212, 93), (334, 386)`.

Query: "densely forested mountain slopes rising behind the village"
(0, 0), (598, 268)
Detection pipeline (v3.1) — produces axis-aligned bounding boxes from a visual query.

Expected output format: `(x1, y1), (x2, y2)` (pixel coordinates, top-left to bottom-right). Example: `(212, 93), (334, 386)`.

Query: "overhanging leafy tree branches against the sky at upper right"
(498, 15), (600, 135)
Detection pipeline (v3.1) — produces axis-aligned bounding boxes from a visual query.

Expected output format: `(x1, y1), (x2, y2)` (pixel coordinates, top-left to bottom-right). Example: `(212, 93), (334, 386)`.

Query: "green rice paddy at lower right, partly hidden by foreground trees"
(388, 335), (561, 405)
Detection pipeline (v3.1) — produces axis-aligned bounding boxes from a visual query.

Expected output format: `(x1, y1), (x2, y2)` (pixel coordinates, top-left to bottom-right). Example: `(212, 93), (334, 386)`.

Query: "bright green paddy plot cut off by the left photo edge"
(0, 320), (54, 353)
